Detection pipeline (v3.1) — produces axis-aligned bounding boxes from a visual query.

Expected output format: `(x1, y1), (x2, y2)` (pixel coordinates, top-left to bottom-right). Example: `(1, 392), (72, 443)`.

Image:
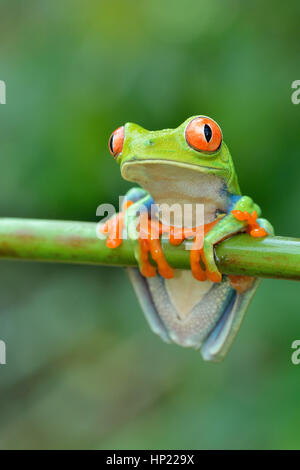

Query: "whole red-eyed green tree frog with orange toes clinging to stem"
(101, 115), (274, 362)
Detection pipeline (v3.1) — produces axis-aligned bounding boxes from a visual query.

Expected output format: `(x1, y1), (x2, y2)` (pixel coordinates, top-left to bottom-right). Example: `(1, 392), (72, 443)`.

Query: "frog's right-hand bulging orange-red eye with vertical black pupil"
(185, 117), (222, 152)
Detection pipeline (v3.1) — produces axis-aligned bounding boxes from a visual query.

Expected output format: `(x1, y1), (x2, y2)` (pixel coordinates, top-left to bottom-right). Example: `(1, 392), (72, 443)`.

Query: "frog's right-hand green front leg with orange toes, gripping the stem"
(201, 196), (274, 284)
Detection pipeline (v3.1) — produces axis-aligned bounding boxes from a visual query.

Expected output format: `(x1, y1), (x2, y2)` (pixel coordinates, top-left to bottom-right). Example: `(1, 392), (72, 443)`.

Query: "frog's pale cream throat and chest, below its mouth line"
(121, 159), (229, 227)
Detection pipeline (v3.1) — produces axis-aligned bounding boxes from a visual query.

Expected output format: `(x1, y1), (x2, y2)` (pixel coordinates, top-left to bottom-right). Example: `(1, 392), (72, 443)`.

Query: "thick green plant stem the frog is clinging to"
(0, 218), (300, 280)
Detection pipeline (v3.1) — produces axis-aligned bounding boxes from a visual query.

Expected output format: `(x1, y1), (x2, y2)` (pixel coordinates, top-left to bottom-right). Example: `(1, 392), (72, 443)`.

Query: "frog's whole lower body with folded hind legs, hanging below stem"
(127, 268), (259, 361)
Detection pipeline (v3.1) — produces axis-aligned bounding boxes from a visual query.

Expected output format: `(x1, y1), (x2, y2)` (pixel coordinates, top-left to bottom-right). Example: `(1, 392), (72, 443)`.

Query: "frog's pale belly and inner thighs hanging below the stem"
(145, 271), (234, 348)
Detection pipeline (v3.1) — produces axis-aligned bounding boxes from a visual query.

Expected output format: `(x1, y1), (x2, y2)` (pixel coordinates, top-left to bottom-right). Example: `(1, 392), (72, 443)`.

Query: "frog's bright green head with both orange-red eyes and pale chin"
(109, 116), (240, 194)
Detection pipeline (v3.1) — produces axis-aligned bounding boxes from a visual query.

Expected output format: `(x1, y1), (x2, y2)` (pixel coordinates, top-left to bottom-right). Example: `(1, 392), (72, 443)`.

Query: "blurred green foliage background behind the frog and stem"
(0, 0), (300, 449)
